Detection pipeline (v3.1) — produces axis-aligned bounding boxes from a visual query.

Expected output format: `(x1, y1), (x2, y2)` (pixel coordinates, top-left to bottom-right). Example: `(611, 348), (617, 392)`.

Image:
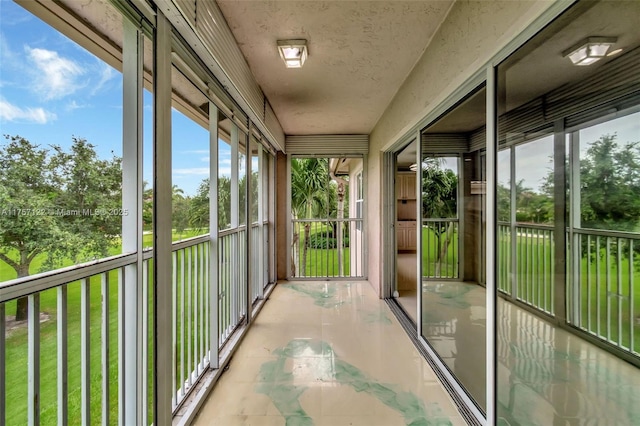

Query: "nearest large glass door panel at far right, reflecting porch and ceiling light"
(496, 1), (640, 425)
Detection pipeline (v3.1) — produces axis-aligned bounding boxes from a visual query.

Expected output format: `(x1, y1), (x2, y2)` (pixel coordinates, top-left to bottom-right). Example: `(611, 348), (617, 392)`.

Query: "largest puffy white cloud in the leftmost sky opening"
(25, 46), (86, 100)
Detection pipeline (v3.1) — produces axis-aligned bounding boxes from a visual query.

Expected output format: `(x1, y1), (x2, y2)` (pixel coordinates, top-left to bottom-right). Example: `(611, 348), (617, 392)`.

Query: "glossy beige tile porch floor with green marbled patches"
(195, 281), (465, 426)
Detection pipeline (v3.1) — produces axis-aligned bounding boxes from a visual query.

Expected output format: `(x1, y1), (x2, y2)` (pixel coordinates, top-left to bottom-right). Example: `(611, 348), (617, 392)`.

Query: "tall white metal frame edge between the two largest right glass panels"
(485, 66), (498, 425)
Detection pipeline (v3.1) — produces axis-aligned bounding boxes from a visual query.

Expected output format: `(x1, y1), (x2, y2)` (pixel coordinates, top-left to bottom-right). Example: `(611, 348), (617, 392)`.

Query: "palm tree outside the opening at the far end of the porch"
(291, 158), (329, 276)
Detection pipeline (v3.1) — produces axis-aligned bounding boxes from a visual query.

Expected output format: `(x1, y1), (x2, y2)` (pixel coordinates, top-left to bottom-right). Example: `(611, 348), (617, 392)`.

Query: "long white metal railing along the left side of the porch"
(0, 230), (268, 425)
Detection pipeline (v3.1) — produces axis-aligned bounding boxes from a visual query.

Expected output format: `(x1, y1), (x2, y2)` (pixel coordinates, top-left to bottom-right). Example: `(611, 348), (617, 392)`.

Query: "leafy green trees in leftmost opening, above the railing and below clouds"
(0, 136), (121, 320)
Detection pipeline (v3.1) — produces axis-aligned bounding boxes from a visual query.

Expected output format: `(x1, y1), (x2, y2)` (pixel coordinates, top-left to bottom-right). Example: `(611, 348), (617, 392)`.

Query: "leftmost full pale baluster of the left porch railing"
(27, 293), (40, 426)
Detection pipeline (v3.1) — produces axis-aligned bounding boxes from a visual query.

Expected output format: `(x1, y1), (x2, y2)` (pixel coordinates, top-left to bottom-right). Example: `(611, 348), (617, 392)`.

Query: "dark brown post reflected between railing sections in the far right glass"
(552, 120), (568, 323)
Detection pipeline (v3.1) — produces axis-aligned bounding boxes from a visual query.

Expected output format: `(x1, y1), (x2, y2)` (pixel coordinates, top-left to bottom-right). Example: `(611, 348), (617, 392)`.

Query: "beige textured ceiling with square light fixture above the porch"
(218, 0), (452, 135)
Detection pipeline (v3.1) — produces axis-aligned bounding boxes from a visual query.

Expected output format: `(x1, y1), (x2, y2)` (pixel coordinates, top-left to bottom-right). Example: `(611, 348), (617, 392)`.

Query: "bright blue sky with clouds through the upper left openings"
(0, 0), (231, 195)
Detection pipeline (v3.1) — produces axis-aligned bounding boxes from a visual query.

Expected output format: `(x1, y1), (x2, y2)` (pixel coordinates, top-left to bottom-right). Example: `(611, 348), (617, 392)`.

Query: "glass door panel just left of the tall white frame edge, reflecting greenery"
(419, 87), (486, 417)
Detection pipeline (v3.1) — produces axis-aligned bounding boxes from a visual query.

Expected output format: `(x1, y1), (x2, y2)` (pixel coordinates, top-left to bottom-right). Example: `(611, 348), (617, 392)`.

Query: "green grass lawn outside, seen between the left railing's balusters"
(0, 231), (199, 425)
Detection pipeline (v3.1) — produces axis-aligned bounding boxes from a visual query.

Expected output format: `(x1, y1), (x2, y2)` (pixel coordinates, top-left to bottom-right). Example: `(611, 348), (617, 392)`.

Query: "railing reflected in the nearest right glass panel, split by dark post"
(497, 223), (640, 355)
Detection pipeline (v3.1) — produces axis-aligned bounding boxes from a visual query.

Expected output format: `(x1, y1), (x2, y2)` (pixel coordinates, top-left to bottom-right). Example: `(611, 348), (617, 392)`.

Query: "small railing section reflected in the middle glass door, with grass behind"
(418, 219), (459, 279)
